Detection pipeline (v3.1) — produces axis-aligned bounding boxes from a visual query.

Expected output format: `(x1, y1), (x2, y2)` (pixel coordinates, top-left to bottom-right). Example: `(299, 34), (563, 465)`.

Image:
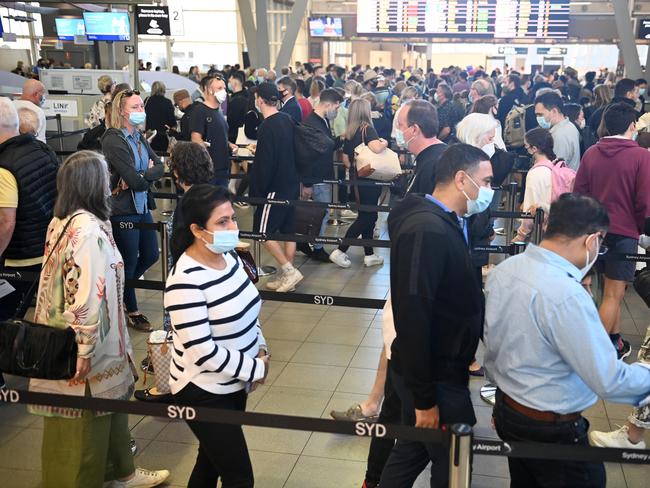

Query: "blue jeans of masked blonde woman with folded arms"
(111, 212), (159, 313)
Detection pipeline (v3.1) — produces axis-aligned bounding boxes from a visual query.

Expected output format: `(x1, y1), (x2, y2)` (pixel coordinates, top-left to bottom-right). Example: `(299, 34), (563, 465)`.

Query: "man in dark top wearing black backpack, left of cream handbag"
(298, 88), (343, 263)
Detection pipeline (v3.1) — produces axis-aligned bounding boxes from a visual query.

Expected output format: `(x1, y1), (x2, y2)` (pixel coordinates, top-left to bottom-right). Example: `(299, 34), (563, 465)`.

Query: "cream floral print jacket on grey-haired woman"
(29, 210), (133, 418)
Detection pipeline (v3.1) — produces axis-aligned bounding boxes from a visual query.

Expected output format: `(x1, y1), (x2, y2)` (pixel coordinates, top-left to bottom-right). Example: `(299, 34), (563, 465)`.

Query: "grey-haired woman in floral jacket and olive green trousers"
(29, 151), (169, 488)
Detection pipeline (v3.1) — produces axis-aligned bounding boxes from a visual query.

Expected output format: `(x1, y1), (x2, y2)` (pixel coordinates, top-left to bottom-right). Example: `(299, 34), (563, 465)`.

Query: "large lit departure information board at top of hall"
(357, 0), (570, 39)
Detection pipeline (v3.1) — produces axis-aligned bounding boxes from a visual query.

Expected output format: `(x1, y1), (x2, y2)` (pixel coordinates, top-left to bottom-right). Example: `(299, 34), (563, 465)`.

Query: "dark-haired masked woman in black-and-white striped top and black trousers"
(165, 185), (270, 488)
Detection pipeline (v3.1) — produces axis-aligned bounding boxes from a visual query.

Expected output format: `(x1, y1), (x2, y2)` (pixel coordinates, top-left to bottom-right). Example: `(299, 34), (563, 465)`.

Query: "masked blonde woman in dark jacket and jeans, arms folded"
(102, 90), (163, 332)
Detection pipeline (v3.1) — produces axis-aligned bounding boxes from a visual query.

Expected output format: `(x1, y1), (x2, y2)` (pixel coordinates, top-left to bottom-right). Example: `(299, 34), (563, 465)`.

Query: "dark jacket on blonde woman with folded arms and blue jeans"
(102, 128), (164, 215)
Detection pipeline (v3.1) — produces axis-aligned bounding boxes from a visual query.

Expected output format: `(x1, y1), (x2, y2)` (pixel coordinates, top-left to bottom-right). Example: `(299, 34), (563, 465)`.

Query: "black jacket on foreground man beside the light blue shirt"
(388, 195), (484, 410)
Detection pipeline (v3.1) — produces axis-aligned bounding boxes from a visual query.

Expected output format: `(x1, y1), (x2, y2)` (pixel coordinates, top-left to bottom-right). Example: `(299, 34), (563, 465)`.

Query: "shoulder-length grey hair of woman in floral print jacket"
(54, 151), (111, 221)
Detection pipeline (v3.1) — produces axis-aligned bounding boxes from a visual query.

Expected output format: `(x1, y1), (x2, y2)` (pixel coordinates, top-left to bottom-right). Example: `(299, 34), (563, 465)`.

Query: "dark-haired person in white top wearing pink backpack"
(513, 127), (557, 242)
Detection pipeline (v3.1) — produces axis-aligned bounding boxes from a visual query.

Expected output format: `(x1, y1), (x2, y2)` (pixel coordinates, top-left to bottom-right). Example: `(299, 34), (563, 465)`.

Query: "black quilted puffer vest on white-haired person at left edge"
(0, 134), (58, 259)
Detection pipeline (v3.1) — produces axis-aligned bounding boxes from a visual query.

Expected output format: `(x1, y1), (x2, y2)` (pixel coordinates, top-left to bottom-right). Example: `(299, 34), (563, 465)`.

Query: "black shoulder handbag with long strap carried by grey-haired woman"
(0, 214), (79, 380)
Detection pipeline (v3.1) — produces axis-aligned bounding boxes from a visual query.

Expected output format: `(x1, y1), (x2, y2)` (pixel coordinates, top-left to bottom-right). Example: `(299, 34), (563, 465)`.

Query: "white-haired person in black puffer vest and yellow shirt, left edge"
(0, 98), (58, 354)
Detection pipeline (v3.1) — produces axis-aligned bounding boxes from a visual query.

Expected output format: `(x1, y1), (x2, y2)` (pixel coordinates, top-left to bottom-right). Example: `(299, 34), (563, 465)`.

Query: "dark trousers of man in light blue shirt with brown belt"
(494, 391), (607, 488)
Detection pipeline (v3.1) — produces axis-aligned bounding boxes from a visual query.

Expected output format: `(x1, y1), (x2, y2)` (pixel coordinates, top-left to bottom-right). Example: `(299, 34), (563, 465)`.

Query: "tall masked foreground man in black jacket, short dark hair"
(380, 144), (492, 488)
